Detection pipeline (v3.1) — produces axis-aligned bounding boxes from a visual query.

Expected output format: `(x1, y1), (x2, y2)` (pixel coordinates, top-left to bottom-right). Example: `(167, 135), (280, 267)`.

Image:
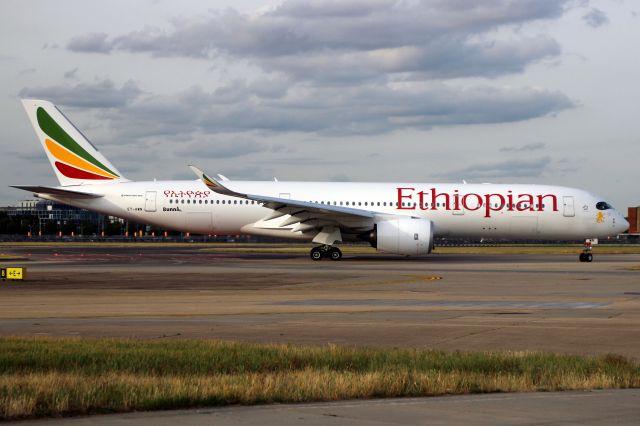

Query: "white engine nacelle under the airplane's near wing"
(370, 217), (433, 256)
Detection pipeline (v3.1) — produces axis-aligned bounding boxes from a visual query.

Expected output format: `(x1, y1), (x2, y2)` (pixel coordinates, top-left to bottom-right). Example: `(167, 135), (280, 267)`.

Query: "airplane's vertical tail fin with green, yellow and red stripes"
(22, 99), (127, 186)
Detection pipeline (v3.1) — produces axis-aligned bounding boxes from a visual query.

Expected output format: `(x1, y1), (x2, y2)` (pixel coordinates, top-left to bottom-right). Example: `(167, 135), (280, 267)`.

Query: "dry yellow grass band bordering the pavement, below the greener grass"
(0, 369), (638, 419)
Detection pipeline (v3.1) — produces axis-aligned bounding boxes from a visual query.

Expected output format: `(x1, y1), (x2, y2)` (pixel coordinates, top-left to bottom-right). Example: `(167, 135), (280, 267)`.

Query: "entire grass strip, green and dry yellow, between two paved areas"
(0, 338), (640, 420)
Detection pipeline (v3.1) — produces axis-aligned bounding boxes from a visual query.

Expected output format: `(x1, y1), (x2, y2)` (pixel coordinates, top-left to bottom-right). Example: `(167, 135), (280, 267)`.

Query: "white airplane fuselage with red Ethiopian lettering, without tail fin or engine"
(40, 180), (627, 239)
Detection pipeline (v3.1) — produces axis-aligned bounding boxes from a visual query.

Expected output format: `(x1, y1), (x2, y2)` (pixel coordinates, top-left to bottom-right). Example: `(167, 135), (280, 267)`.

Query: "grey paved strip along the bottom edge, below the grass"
(8, 389), (640, 426)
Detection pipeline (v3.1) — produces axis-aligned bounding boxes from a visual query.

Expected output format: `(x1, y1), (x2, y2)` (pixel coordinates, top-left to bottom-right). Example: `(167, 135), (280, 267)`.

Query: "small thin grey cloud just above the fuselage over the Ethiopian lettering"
(436, 156), (551, 180)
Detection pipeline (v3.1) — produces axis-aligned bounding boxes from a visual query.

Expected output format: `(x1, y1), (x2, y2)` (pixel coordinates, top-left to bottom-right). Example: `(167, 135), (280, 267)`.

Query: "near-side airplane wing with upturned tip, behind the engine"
(189, 166), (379, 244)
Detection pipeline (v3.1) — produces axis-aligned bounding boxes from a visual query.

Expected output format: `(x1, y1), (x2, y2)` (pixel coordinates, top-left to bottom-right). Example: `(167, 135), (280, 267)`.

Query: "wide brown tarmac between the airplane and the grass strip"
(0, 244), (640, 359)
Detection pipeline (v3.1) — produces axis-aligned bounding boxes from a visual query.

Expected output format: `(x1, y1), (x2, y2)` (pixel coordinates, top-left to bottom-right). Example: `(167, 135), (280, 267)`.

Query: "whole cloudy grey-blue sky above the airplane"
(0, 0), (640, 208)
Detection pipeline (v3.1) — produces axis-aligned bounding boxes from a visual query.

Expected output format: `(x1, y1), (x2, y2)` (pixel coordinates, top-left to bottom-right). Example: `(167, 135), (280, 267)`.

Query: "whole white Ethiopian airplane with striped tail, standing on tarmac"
(13, 99), (629, 262)
